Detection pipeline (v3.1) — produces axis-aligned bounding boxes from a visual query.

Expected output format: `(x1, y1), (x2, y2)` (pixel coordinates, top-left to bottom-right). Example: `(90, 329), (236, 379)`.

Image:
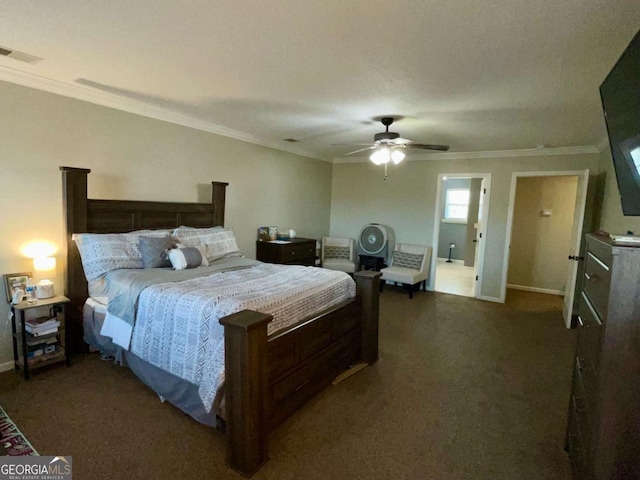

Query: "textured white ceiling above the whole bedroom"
(0, 0), (640, 160)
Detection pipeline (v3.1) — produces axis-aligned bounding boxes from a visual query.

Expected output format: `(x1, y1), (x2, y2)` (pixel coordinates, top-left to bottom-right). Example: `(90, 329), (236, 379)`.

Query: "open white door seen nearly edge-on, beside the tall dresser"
(562, 170), (589, 328)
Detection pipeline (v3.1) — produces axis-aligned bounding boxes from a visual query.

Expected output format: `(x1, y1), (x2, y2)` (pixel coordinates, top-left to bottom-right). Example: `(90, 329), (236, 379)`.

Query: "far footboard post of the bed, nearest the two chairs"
(354, 270), (381, 365)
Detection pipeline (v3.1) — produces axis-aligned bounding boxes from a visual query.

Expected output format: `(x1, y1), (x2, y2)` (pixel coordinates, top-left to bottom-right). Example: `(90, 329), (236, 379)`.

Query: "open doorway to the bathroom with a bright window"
(430, 173), (491, 297)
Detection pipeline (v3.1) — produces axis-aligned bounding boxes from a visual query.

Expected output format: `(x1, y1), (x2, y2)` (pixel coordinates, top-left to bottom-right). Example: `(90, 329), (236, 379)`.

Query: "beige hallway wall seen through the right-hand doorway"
(507, 177), (578, 293)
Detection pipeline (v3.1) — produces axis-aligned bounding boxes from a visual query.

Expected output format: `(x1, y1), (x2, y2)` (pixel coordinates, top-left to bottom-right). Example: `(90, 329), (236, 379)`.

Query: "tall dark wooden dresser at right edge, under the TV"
(566, 235), (640, 480)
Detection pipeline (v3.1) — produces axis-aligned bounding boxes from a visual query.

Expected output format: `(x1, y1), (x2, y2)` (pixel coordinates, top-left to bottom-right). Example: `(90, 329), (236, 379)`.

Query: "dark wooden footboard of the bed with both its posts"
(220, 271), (380, 476)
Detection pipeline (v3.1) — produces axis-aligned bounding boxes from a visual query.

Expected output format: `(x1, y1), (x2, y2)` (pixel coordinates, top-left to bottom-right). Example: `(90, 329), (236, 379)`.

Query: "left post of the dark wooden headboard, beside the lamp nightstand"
(60, 167), (91, 353)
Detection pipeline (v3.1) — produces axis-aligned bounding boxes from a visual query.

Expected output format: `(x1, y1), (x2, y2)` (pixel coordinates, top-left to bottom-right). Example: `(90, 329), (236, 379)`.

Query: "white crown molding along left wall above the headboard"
(0, 65), (327, 161)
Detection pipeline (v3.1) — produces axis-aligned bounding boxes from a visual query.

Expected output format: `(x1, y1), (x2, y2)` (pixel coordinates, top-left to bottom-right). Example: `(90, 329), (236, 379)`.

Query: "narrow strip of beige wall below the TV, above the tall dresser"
(600, 147), (640, 235)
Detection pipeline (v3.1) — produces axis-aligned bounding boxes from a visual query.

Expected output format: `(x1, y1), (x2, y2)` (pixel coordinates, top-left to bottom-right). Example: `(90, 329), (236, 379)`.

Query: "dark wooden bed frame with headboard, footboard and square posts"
(60, 167), (380, 476)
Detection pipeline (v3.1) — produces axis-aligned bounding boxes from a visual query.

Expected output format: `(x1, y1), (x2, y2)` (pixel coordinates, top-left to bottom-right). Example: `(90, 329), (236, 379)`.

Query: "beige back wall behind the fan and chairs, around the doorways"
(331, 154), (599, 299)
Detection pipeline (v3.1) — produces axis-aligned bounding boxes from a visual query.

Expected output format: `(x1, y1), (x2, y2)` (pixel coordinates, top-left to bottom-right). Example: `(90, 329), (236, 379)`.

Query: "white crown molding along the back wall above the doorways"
(333, 145), (601, 163)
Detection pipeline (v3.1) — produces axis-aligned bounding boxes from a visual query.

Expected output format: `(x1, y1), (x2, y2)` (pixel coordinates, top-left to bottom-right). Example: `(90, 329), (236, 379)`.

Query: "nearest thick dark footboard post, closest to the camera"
(220, 310), (273, 476)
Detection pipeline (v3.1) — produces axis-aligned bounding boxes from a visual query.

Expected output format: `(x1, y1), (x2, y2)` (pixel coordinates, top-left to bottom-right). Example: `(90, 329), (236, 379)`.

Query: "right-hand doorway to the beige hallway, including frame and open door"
(501, 170), (589, 328)
